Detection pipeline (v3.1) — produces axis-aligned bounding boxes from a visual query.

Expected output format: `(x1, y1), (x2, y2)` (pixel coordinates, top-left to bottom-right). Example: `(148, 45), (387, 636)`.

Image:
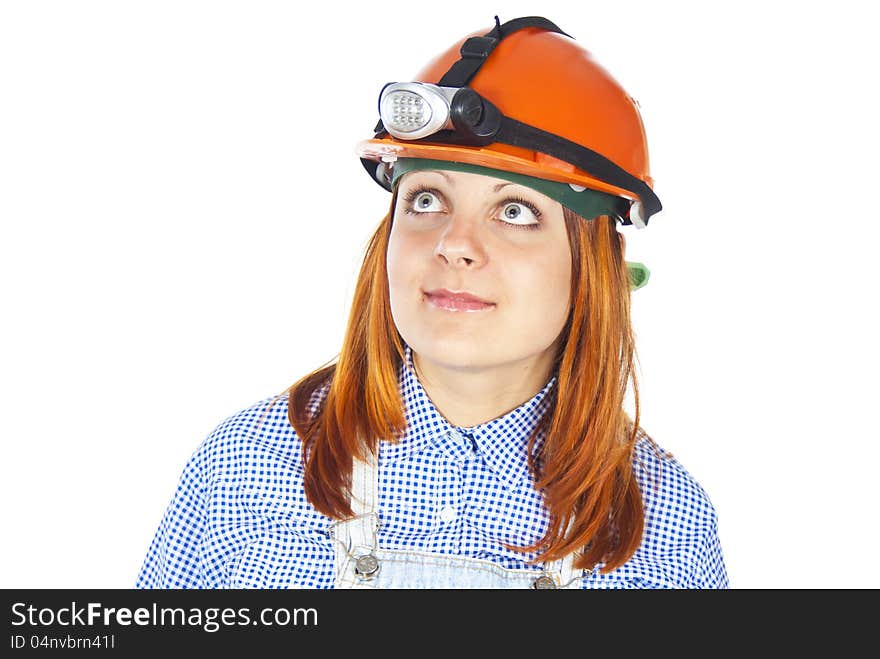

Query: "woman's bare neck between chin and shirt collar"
(413, 350), (554, 428)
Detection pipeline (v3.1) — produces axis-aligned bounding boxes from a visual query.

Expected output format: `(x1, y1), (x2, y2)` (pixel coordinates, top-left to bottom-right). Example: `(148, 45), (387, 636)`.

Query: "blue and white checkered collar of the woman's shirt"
(379, 344), (556, 488)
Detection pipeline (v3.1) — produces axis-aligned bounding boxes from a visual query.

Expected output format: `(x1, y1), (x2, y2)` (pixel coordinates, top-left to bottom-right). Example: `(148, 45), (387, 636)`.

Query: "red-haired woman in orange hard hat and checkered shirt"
(137, 17), (728, 588)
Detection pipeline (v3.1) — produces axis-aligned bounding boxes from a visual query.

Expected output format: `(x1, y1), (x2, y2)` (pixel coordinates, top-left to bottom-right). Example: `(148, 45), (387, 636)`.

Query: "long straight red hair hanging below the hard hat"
(281, 193), (644, 572)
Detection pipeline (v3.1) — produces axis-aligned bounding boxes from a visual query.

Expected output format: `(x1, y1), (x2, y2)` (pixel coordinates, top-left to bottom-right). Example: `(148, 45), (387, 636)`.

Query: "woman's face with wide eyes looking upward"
(387, 170), (571, 370)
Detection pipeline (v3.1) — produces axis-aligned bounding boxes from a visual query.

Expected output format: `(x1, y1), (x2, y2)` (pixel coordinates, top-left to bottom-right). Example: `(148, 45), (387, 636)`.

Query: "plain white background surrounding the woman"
(0, 0), (880, 588)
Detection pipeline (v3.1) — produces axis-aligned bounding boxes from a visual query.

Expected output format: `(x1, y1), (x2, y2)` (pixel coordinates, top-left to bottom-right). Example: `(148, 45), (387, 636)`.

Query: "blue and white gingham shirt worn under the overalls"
(136, 347), (728, 588)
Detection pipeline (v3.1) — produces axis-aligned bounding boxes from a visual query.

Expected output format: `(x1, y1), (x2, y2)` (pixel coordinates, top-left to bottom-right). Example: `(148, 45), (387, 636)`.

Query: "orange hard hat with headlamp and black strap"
(356, 16), (662, 227)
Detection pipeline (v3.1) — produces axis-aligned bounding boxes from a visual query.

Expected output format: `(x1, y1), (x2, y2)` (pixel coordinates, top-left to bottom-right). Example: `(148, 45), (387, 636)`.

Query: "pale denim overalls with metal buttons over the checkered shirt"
(331, 456), (585, 589)
